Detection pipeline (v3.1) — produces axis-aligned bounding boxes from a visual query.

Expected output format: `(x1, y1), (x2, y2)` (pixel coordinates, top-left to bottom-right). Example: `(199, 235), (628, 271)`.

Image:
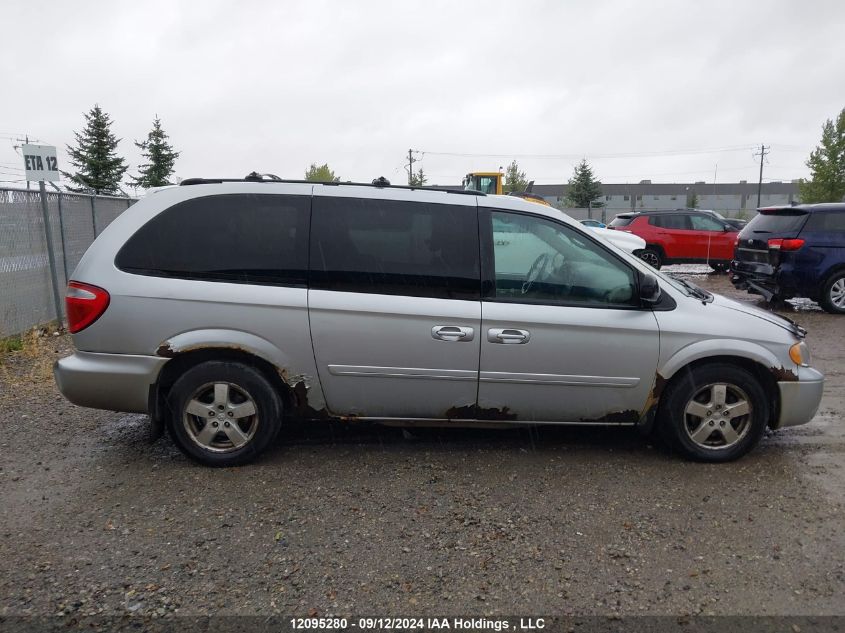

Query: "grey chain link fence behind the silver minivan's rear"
(0, 188), (135, 338)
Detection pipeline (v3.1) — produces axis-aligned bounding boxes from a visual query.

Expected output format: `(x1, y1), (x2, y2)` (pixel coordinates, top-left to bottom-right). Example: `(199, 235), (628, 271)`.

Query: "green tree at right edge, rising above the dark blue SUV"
(799, 108), (845, 203)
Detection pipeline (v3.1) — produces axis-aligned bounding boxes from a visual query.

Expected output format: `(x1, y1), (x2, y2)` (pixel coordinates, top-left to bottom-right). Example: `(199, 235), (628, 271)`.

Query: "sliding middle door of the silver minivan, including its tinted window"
(308, 187), (481, 418)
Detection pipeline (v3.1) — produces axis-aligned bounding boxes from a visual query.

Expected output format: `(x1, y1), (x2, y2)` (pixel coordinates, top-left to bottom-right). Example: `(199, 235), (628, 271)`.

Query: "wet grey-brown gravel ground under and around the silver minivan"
(0, 268), (845, 616)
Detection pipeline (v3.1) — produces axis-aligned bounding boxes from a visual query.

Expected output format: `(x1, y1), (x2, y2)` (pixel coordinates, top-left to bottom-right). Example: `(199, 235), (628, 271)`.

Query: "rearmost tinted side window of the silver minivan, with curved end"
(115, 194), (310, 286)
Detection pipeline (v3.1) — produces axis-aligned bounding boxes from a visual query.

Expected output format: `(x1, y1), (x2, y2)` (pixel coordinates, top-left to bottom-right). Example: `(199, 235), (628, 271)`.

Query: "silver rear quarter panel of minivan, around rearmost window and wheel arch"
(67, 183), (323, 409)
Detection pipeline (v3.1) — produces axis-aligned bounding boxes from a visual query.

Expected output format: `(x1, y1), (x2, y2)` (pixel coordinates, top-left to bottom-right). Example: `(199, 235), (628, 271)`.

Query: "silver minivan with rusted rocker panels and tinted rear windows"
(55, 176), (824, 466)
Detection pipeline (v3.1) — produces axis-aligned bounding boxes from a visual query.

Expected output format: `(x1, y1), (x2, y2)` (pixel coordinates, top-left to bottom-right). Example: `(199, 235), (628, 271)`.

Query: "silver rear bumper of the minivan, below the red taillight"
(53, 351), (167, 413)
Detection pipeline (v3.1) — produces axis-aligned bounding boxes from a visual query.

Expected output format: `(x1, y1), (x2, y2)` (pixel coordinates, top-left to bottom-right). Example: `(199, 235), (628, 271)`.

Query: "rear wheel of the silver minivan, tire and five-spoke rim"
(167, 361), (283, 466)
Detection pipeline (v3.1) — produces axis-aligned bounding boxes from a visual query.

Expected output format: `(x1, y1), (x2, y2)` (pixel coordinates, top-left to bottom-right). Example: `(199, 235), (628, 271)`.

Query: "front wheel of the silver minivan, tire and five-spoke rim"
(658, 363), (770, 462)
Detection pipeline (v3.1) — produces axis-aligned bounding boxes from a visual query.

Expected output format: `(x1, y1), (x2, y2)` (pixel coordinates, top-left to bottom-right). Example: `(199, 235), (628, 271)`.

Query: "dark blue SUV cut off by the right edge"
(731, 203), (845, 314)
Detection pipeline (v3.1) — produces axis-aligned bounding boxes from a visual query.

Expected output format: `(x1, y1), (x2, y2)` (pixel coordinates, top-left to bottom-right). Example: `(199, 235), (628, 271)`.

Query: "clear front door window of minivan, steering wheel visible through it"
(485, 211), (638, 307)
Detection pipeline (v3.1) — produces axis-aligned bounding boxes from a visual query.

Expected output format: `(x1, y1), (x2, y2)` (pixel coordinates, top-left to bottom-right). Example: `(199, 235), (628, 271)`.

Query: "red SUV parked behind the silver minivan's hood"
(608, 210), (739, 271)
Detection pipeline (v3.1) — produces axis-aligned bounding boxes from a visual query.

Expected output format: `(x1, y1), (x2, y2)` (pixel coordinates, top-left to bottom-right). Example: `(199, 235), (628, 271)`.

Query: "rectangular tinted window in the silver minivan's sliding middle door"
(310, 197), (481, 300)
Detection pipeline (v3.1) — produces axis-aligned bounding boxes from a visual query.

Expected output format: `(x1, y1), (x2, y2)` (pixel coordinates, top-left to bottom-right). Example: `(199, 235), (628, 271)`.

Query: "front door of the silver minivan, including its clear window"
(478, 210), (659, 423)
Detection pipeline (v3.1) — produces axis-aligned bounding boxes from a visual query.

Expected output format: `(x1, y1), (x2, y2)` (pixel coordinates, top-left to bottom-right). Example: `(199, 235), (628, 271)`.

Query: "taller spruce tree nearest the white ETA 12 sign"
(62, 104), (127, 195)
